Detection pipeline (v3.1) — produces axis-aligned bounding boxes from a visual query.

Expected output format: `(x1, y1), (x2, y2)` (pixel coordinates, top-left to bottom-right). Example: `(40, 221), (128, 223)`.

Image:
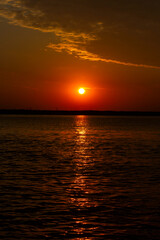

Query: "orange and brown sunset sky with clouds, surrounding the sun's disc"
(0, 0), (160, 111)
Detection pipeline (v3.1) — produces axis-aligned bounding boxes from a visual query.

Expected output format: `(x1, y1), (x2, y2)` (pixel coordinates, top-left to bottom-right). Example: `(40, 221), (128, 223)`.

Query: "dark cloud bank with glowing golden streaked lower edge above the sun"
(0, 0), (160, 69)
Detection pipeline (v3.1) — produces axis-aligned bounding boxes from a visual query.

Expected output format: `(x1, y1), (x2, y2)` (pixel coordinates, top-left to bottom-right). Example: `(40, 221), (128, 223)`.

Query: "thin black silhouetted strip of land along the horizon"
(0, 109), (160, 116)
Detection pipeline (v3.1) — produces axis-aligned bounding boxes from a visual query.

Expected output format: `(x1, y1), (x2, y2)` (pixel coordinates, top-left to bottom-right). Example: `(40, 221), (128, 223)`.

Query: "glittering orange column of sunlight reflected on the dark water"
(67, 116), (97, 240)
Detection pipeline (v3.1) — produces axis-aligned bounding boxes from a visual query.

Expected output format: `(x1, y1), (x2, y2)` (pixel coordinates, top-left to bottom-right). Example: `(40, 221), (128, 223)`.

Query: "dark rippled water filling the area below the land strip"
(0, 116), (160, 240)
